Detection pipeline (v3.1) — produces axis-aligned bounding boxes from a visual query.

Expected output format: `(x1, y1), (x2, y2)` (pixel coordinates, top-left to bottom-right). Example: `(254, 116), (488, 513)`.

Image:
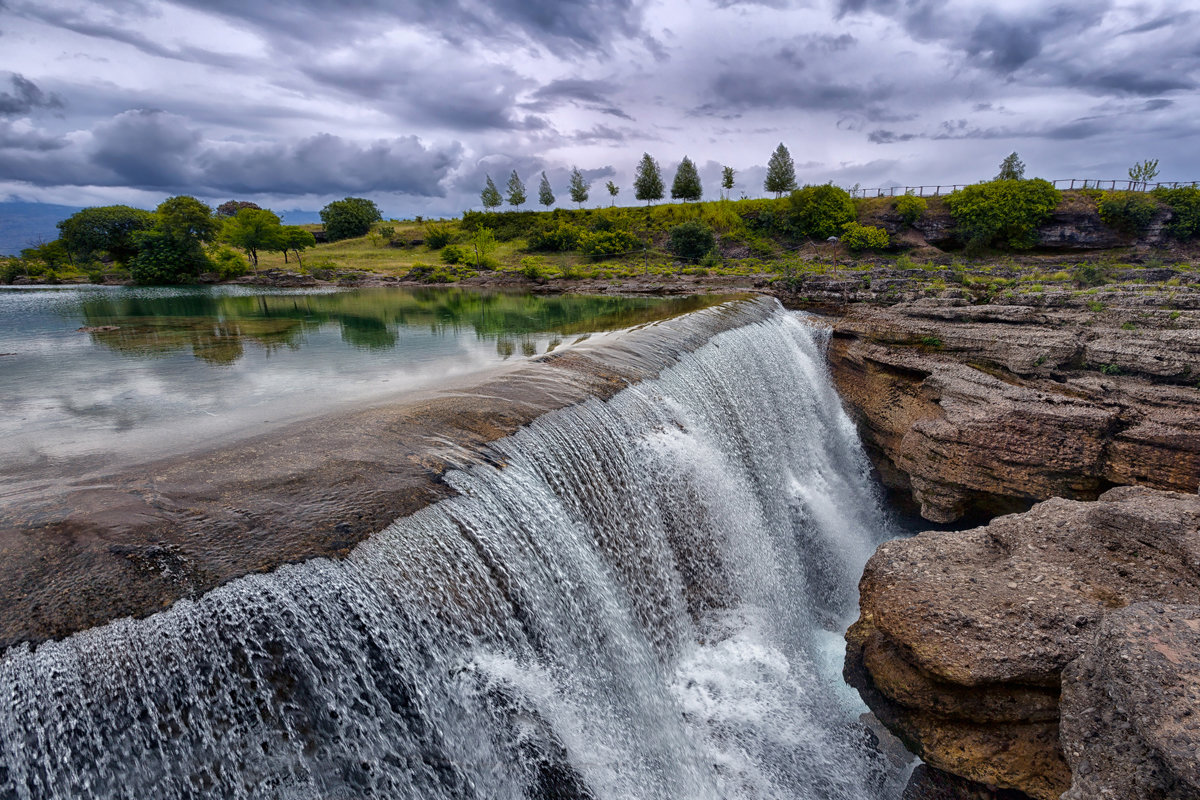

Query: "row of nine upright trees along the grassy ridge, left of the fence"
(479, 142), (797, 210)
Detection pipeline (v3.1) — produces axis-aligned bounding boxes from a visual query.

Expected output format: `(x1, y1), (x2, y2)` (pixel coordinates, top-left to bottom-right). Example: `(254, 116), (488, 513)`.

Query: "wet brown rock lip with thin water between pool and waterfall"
(0, 293), (778, 650)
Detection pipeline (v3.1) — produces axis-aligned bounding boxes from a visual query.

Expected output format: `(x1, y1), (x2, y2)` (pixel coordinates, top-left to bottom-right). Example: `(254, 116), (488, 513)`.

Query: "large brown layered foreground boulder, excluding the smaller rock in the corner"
(845, 487), (1200, 800)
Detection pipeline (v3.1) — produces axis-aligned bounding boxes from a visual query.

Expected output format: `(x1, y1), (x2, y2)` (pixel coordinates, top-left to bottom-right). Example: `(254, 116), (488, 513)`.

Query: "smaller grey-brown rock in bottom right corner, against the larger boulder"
(1062, 603), (1200, 800)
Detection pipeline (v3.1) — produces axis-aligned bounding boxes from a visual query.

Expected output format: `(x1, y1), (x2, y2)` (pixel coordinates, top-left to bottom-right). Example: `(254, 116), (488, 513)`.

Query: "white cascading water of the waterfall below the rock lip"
(0, 311), (892, 800)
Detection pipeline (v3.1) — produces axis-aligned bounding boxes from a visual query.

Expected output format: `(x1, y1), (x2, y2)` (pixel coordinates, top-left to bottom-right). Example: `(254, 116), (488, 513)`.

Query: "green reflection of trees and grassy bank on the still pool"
(83, 288), (729, 365)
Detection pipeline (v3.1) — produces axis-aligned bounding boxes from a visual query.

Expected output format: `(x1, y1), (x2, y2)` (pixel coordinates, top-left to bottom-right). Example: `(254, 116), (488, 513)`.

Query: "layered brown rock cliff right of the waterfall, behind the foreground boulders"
(830, 299), (1200, 522)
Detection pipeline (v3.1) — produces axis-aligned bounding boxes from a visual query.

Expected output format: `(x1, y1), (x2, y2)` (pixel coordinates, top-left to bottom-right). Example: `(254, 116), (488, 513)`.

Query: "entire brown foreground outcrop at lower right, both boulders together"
(846, 487), (1200, 800)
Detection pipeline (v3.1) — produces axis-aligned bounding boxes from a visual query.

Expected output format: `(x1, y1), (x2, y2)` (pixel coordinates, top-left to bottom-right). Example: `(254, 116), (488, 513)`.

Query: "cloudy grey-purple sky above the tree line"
(0, 0), (1200, 216)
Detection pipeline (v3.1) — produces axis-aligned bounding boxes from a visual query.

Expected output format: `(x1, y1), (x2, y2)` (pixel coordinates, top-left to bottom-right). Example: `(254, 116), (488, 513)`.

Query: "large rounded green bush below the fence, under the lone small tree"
(946, 178), (1062, 249)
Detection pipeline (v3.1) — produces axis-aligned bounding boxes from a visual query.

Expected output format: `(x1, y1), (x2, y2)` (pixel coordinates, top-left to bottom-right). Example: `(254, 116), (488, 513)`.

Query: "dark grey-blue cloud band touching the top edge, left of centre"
(169, 0), (641, 52)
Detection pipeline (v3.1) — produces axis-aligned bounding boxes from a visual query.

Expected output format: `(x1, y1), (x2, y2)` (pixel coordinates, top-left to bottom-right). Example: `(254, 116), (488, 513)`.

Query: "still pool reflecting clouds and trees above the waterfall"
(0, 287), (721, 499)
